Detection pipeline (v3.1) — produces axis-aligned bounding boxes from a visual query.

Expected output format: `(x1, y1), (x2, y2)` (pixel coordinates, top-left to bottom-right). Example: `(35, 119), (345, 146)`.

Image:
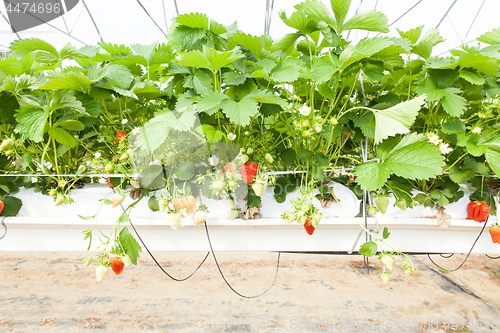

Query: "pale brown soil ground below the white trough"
(0, 252), (500, 333)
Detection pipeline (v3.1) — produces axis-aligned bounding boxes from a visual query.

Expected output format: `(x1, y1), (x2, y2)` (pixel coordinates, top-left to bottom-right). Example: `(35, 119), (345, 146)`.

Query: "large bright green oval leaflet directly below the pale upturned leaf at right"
(384, 141), (445, 179)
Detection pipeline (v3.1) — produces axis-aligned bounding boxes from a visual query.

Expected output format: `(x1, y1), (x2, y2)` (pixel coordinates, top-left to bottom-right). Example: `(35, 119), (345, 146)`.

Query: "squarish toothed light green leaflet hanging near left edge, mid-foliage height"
(15, 106), (49, 142)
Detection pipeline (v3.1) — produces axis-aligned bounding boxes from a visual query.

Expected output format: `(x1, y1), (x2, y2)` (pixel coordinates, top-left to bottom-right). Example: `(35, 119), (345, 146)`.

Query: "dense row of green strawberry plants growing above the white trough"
(0, 0), (500, 281)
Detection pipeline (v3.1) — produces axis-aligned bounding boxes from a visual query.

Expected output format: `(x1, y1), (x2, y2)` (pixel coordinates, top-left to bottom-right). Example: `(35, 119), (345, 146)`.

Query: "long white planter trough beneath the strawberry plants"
(0, 184), (500, 255)
